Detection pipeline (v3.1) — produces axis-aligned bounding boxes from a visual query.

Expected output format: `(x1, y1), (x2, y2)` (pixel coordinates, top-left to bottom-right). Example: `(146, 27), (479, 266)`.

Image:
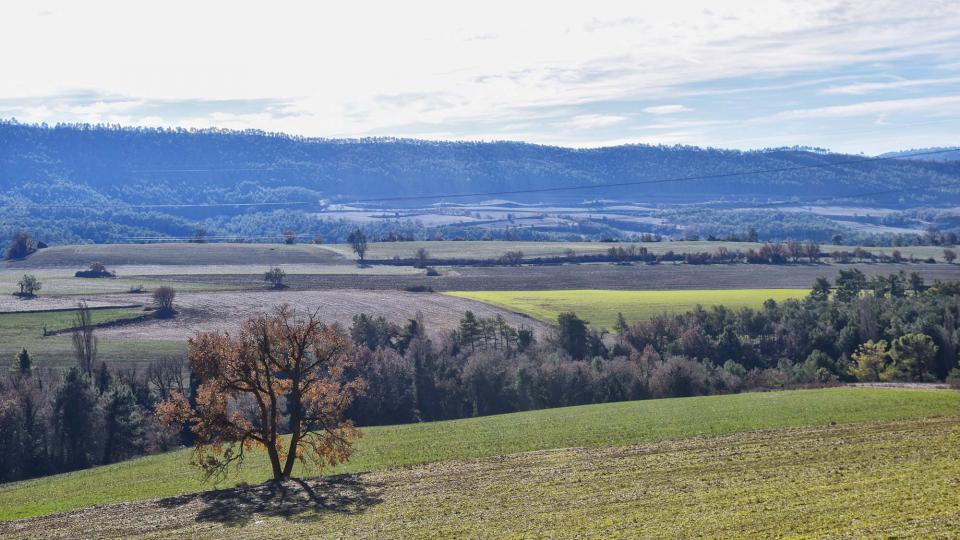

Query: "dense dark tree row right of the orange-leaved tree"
(342, 270), (960, 424)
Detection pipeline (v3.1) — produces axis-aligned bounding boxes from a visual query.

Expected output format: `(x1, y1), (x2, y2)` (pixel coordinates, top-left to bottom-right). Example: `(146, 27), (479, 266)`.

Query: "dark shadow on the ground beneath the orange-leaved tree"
(160, 474), (382, 527)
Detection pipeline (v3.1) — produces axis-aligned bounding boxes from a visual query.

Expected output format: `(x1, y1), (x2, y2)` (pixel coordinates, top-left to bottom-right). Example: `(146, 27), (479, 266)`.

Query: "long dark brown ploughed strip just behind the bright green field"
(145, 263), (960, 291)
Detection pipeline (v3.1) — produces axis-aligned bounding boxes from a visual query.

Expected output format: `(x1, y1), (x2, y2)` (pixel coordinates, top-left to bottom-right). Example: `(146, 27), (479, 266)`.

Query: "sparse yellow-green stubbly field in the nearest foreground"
(15, 417), (960, 540)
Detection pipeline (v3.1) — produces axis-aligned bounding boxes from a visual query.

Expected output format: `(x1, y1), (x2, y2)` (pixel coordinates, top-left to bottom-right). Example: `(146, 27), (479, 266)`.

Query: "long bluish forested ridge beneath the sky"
(0, 121), (960, 241)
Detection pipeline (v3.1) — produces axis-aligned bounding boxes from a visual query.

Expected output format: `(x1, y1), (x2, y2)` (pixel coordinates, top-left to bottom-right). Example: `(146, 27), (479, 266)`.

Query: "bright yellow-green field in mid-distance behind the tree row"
(443, 289), (809, 329)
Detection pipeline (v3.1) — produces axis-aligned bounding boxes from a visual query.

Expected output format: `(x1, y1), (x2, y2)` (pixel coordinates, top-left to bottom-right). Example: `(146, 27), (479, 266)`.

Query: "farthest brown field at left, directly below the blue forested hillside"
(2, 243), (352, 270)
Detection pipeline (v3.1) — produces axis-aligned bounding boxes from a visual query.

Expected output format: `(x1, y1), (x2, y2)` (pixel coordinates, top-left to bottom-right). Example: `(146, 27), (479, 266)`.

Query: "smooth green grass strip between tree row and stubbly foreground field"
(0, 388), (960, 520)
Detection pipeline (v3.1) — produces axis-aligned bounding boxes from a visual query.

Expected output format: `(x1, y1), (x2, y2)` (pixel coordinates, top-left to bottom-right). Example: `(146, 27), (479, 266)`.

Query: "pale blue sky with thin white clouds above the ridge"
(0, 0), (960, 154)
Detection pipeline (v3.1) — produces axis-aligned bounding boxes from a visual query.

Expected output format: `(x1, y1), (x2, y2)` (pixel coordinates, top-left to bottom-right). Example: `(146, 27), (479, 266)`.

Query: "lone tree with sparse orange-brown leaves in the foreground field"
(157, 306), (366, 480)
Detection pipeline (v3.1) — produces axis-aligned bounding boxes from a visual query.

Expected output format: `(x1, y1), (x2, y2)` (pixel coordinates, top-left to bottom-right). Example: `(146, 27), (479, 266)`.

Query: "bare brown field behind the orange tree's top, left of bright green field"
(98, 289), (549, 341)
